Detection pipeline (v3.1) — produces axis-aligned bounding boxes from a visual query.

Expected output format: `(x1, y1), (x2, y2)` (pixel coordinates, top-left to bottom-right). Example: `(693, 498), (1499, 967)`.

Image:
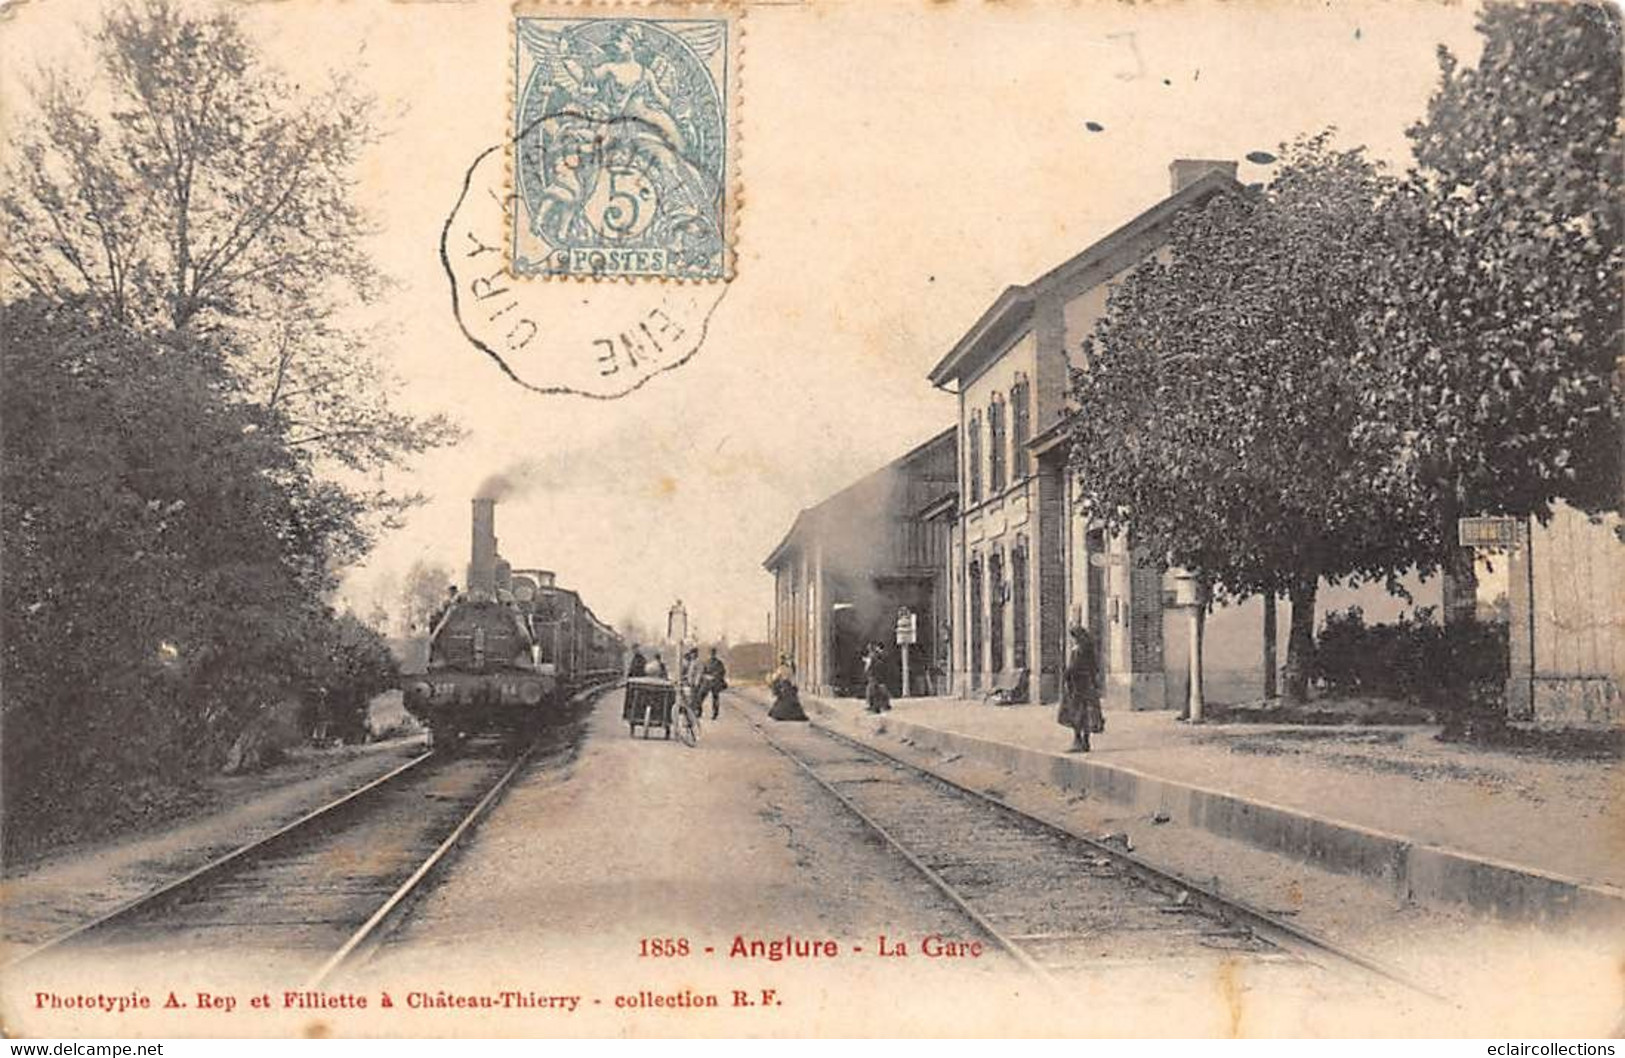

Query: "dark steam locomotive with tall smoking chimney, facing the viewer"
(403, 499), (626, 748)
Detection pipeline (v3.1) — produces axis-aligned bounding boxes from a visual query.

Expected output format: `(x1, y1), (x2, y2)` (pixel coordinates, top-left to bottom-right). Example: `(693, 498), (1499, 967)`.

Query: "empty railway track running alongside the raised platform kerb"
(741, 707), (1441, 1001)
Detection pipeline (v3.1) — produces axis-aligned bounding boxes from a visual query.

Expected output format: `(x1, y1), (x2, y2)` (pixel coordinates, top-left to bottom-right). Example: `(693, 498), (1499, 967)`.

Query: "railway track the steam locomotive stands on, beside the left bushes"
(8, 689), (601, 988)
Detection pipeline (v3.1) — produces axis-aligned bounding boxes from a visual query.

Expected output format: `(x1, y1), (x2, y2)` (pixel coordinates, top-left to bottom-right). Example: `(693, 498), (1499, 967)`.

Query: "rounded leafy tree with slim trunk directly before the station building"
(1071, 135), (1435, 700)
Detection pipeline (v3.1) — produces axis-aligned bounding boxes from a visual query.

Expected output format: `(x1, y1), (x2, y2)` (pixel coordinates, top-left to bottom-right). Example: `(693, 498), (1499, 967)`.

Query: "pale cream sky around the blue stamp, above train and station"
(0, 0), (1477, 639)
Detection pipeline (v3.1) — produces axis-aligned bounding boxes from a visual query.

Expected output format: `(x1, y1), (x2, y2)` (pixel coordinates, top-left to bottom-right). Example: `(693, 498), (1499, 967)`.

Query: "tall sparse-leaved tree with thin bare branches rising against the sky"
(0, 0), (457, 494)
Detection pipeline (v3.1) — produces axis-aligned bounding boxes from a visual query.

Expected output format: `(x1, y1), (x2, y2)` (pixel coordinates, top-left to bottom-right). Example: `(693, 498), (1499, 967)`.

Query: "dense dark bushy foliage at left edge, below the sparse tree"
(0, 297), (361, 847)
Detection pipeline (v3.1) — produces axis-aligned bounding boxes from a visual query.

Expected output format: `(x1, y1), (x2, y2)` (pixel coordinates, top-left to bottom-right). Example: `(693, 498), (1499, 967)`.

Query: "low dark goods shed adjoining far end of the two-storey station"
(764, 429), (957, 694)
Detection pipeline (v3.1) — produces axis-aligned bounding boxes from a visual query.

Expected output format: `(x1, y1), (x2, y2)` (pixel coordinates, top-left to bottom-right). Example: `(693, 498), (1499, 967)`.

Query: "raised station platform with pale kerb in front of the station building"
(752, 689), (1625, 923)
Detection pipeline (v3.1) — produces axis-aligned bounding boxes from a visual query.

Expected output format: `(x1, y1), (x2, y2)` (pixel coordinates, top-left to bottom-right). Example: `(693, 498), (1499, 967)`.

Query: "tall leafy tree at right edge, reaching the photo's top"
(1360, 3), (1625, 594)
